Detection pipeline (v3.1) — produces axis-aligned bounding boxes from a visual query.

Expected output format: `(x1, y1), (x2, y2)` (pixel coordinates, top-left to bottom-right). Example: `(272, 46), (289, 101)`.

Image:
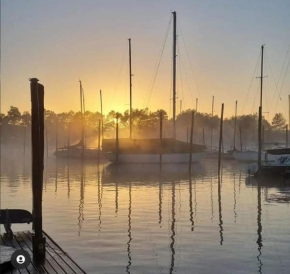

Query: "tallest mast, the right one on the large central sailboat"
(172, 11), (176, 139)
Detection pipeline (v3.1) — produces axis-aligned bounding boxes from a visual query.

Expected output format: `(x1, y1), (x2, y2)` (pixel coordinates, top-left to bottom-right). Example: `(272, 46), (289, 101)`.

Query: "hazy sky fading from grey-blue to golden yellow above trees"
(1, 0), (290, 118)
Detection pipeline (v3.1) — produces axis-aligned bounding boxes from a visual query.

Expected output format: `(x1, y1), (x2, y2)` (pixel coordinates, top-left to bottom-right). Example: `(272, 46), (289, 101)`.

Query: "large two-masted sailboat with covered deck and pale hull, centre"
(102, 11), (205, 164)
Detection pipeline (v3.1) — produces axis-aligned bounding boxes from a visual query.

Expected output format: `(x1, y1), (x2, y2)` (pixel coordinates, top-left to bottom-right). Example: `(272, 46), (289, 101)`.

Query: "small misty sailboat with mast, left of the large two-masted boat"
(54, 81), (100, 159)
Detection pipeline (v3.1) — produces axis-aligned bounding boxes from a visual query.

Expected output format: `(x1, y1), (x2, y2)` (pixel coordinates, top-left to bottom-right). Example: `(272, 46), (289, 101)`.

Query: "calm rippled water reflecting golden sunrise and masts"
(1, 155), (290, 274)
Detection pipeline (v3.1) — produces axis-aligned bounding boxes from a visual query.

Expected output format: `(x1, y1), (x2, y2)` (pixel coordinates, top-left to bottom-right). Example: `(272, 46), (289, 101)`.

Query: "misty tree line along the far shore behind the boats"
(0, 106), (286, 152)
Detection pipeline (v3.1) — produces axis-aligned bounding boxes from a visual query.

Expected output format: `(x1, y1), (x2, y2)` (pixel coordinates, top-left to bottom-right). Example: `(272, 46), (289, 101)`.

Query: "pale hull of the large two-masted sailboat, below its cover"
(105, 152), (205, 164)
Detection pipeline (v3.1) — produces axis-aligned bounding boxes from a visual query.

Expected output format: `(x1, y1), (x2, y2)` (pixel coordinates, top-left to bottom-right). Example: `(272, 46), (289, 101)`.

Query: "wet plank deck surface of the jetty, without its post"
(0, 230), (86, 274)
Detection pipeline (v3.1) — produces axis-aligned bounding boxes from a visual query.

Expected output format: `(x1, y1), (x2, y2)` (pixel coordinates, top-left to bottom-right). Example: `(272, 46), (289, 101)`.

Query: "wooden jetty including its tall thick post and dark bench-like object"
(0, 78), (85, 274)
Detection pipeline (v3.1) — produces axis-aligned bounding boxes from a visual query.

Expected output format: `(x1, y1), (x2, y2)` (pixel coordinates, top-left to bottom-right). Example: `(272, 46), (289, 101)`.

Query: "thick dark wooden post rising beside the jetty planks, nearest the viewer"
(30, 78), (45, 264)
